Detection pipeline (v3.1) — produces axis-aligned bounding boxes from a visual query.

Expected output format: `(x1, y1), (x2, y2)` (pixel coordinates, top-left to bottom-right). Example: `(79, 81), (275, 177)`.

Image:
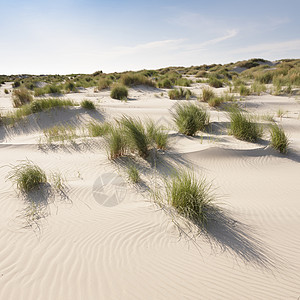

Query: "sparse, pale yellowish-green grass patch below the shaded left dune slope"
(43, 125), (77, 144)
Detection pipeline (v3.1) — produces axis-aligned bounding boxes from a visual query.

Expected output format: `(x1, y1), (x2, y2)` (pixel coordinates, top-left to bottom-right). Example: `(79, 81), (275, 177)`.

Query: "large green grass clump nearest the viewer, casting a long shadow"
(166, 170), (214, 226)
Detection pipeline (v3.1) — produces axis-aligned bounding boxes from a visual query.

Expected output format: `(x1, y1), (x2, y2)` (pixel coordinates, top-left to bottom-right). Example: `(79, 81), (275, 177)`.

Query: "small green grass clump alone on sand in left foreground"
(7, 161), (47, 193)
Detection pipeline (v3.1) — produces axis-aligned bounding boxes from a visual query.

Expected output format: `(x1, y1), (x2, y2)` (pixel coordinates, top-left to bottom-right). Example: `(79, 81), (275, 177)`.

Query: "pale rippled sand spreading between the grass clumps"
(0, 81), (300, 300)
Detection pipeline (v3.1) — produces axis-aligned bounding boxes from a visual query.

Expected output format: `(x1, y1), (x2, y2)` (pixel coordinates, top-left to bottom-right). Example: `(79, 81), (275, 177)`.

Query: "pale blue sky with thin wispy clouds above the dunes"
(0, 0), (300, 74)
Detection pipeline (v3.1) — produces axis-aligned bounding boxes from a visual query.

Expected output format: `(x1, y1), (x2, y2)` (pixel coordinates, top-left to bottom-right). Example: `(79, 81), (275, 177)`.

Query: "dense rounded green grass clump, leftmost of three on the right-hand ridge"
(173, 103), (209, 136)
